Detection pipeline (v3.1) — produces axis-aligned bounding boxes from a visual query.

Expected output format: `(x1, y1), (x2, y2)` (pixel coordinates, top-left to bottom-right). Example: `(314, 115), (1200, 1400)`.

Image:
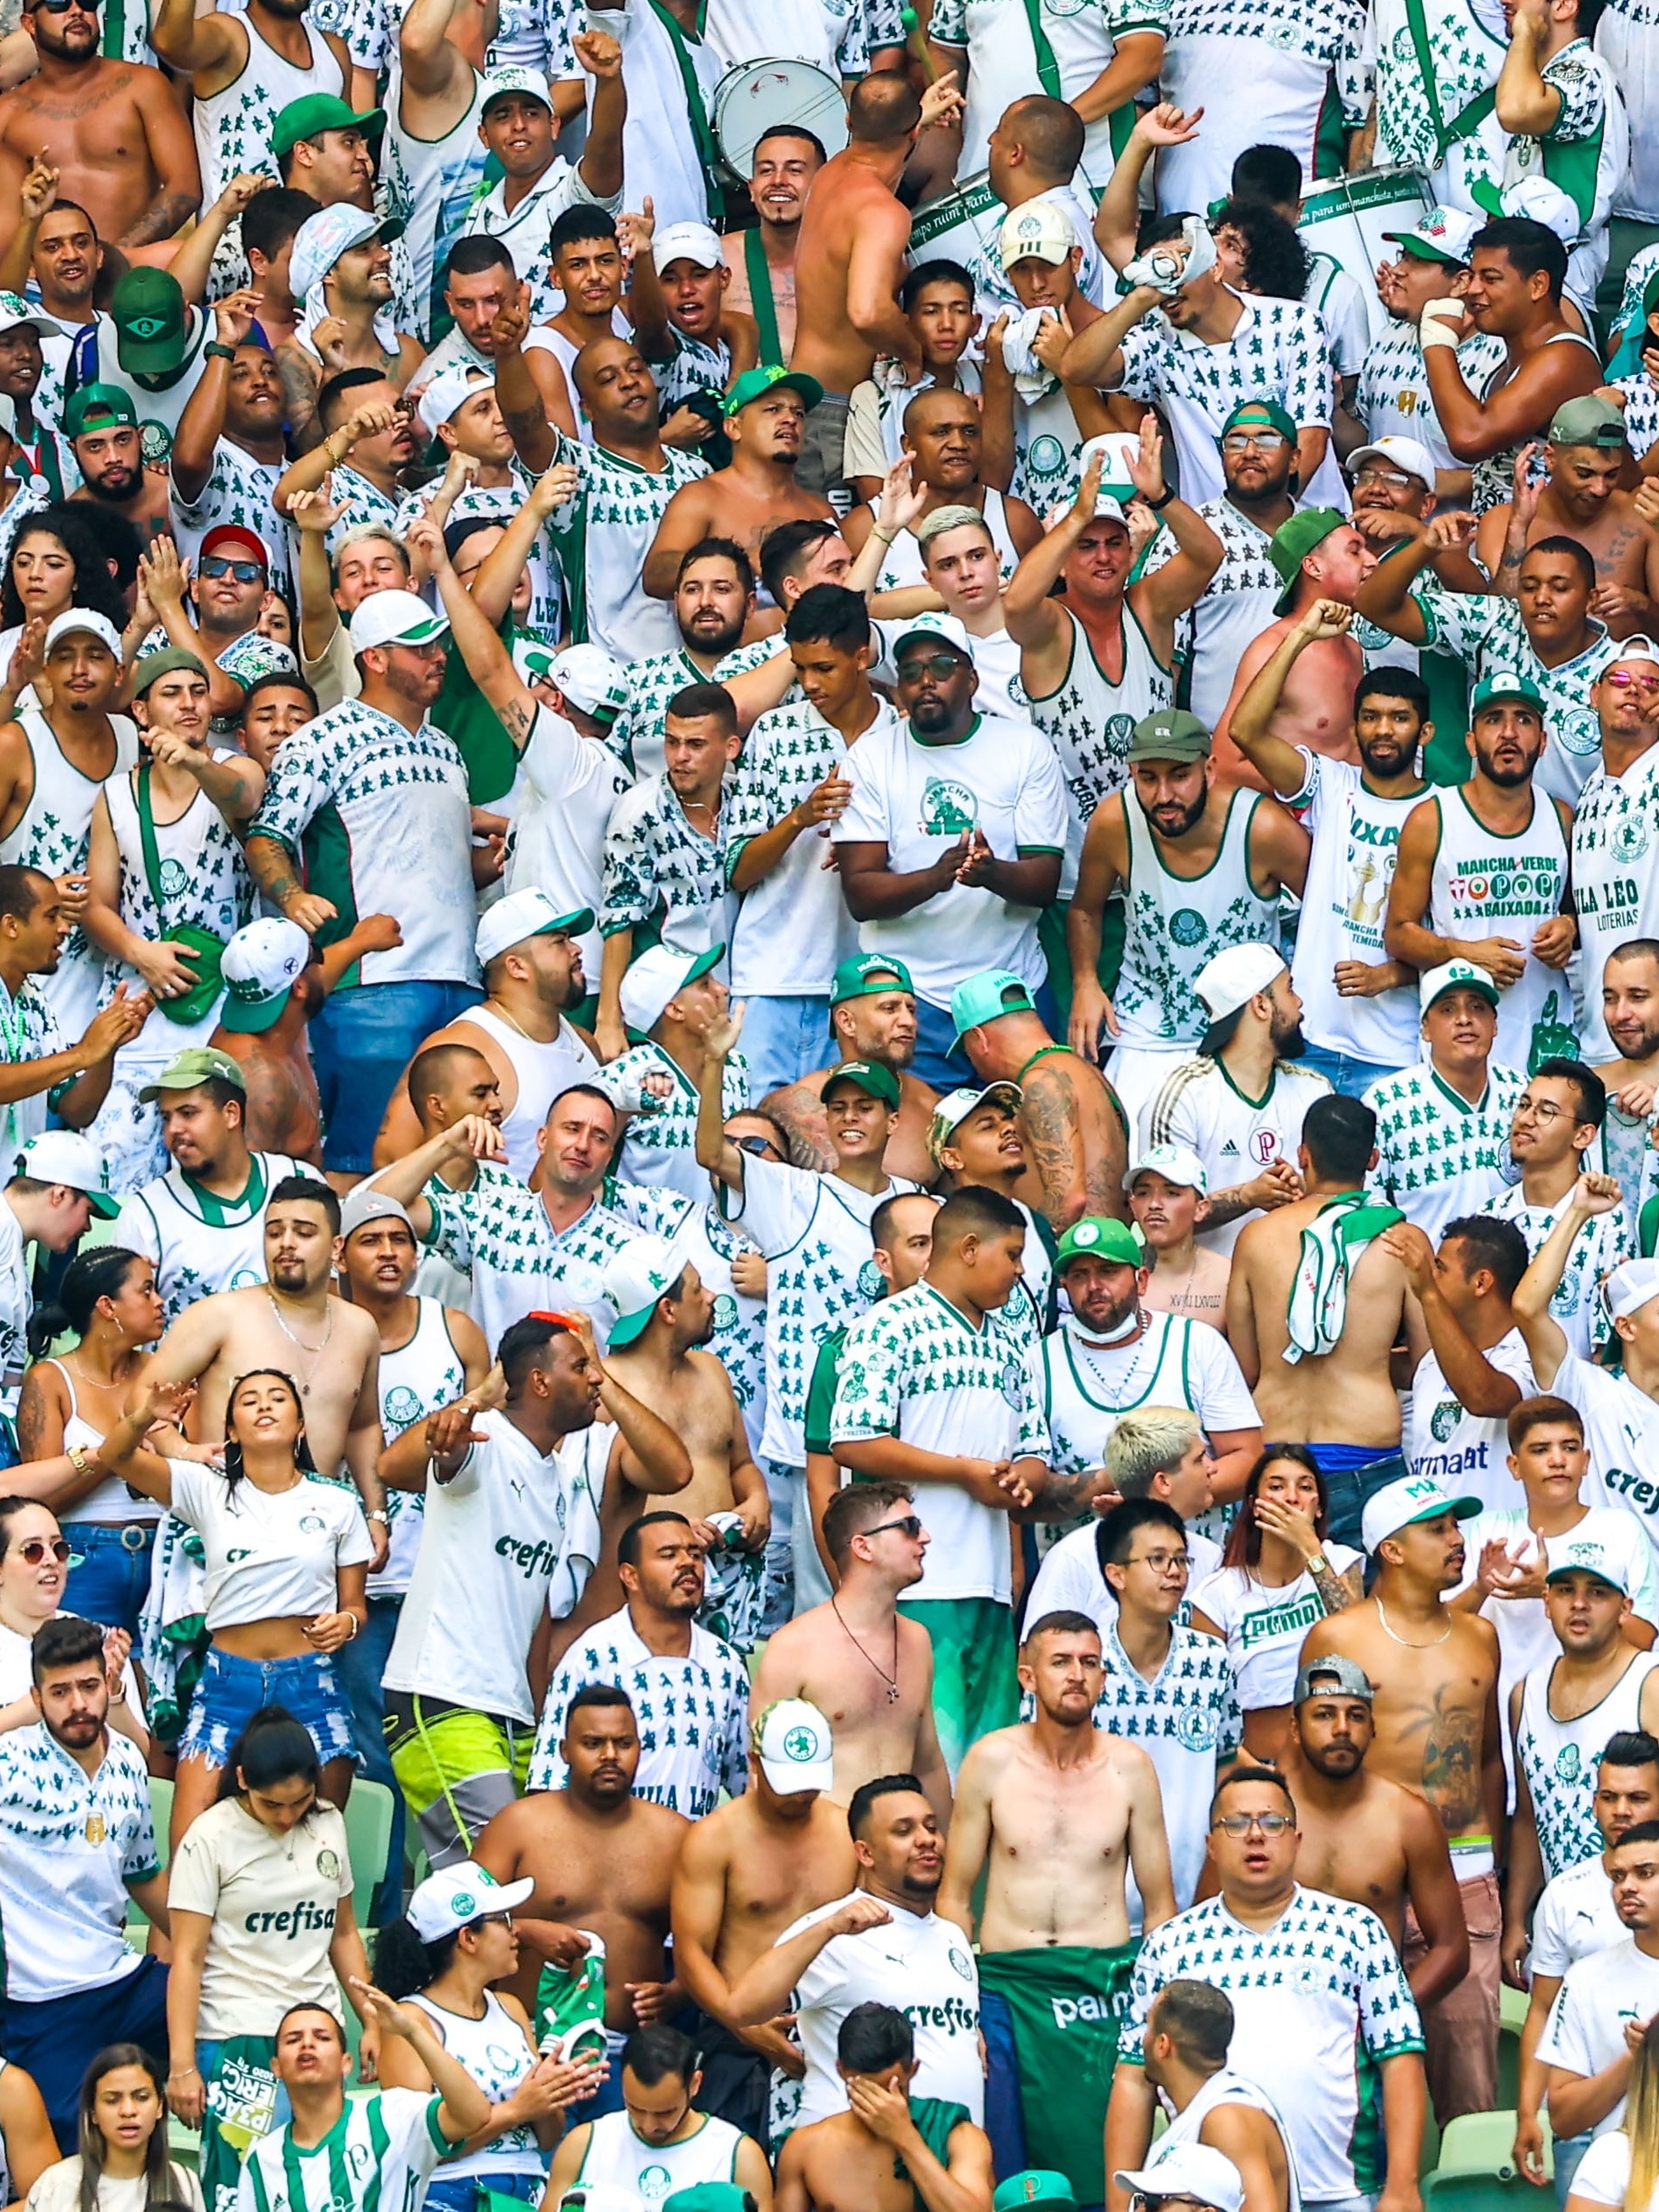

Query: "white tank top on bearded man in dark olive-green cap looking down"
(1112, 792), (1279, 1051)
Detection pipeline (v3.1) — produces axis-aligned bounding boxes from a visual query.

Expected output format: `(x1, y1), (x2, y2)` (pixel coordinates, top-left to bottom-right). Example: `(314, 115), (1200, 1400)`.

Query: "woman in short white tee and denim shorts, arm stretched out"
(102, 1367), (372, 1847)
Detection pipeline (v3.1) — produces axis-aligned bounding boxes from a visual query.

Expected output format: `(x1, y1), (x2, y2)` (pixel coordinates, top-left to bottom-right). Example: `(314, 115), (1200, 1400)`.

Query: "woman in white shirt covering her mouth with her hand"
(1192, 1444), (1365, 1760)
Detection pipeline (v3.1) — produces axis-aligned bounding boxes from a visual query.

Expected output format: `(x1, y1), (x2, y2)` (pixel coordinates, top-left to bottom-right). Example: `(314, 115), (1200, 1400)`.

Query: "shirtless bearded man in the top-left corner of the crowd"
(0, 0), (201, 257)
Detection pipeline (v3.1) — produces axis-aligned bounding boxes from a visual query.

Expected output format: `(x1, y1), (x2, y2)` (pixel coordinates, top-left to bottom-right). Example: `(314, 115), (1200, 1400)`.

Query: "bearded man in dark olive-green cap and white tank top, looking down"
(1066, 695), (1309, 1132)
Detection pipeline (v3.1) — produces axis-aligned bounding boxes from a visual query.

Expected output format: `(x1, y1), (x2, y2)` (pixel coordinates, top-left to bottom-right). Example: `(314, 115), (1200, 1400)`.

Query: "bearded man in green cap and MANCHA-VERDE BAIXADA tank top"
(1382, 668), (1577, 1068)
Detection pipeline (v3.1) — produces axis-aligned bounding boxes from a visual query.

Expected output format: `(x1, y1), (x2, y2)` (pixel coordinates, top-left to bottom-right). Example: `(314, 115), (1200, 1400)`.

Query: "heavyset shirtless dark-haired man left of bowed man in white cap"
(471, 1681), (690, 2087)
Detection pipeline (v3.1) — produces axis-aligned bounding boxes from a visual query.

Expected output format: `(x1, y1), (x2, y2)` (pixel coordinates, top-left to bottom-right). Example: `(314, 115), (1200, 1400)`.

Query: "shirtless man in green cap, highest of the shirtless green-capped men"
(644, 367), (837, 599)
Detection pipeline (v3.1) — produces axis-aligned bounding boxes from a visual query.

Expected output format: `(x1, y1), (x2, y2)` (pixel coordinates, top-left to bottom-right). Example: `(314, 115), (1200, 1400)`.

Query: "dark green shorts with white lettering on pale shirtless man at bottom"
(980, 1942), (1141, 2205)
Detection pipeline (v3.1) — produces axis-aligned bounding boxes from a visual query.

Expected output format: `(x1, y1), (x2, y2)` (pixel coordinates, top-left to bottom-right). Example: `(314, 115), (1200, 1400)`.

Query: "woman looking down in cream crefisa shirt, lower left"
(168, 1705), (378, 2203)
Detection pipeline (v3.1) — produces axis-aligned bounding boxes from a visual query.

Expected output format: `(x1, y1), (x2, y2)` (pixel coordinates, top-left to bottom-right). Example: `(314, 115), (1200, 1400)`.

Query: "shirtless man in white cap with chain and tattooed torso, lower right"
(1309, 1478), (1506, 2126)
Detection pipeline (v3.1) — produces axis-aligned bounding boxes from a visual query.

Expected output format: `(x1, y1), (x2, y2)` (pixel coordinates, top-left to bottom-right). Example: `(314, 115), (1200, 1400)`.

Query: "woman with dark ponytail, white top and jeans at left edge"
(9, 1246), (163, 1637)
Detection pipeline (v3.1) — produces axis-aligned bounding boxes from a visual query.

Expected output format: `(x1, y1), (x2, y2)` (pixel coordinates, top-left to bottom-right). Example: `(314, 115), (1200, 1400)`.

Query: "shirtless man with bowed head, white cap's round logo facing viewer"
(670, 1674), (858, 2139)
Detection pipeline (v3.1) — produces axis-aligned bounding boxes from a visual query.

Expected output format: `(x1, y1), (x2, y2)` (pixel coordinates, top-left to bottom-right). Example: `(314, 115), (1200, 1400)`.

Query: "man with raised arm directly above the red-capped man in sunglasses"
(168, 292), (294, 602)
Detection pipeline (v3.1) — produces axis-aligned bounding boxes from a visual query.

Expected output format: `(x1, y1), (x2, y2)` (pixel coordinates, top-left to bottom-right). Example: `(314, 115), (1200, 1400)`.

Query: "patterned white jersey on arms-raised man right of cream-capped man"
(1117, 293), (1341, 507)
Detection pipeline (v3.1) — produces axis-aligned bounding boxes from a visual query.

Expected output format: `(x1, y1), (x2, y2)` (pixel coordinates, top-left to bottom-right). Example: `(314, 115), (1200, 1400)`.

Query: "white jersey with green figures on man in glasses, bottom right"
(1117, 1883), (1423, 2205)
